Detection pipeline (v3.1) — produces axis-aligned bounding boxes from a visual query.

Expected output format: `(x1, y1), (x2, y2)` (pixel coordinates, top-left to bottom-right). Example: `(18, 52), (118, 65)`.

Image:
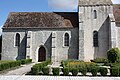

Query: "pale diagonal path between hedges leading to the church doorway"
(2, 63), (35, 76)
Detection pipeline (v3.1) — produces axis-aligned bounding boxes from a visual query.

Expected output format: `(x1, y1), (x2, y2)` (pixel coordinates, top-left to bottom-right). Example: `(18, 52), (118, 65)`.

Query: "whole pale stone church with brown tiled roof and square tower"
(2, 0), (120, 63)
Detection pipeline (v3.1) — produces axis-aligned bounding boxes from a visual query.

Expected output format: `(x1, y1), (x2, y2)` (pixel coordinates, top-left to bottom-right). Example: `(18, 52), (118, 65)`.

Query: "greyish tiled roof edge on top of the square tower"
(79, 0), (112, 6)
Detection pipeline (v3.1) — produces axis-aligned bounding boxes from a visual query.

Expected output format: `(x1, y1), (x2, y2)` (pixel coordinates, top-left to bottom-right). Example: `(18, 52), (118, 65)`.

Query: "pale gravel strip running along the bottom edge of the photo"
(0, 75), (120, 80)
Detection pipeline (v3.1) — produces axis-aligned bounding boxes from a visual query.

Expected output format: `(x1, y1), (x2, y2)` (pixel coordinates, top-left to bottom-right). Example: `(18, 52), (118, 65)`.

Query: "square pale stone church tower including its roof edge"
(78, 0), (114, 61)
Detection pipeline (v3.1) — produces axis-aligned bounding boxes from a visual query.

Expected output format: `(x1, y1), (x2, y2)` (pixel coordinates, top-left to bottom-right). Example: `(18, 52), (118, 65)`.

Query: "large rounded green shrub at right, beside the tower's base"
(107, 48), (120, 63)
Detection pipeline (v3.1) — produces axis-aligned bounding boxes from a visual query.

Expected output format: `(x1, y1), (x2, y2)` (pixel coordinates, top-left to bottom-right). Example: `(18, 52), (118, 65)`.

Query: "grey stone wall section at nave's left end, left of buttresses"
(2, 30), (26, 60)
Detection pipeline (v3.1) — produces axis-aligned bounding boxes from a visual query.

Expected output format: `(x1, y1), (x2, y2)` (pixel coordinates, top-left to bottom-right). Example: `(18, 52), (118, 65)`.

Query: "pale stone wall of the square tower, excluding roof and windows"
(79, 5), (112, 61)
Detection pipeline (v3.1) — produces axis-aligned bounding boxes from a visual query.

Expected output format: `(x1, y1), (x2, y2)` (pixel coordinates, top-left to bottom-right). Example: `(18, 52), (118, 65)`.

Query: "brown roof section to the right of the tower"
(113, 4), (120, 27)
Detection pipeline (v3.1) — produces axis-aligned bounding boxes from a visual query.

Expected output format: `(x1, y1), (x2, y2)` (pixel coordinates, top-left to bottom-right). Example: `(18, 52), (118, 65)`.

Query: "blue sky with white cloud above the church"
(0, 0), (120, 34)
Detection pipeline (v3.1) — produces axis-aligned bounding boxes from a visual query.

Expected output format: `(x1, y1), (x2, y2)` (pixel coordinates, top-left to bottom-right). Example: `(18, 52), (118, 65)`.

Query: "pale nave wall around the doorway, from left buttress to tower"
(30, 28), (79, 62)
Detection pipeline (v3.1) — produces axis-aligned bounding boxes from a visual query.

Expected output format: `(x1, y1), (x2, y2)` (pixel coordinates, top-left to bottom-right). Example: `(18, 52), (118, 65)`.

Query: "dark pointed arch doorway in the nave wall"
(38, 46), (46, 62)
